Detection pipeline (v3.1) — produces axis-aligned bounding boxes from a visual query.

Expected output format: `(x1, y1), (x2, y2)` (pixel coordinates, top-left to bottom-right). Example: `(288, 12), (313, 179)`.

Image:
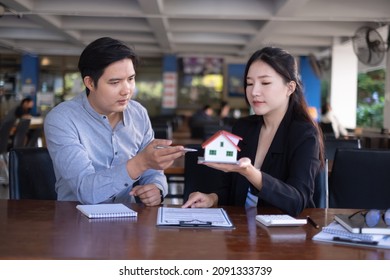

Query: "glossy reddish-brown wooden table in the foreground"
(0, 200), (390, 260)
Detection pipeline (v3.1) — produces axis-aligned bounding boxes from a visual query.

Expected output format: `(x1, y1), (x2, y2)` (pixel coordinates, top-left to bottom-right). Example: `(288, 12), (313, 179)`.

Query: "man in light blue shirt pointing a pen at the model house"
(44, 37), (184, 206)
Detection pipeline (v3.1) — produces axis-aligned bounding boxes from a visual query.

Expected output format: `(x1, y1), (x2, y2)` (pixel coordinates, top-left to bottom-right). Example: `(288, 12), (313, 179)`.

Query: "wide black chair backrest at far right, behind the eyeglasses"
(329, 148), (390, 209)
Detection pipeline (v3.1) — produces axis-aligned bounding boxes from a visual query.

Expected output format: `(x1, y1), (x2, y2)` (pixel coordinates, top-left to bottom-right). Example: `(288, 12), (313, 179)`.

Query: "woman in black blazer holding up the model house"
(183, 47), (324, 216)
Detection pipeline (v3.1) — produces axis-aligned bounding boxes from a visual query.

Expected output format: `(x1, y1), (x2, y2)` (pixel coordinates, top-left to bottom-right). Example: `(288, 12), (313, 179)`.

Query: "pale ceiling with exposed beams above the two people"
(0, 0), (390, 60)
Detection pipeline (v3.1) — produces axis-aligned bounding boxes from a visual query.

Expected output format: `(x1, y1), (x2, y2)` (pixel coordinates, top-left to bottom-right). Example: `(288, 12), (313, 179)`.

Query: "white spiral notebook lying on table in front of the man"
(76, 203), (137, 219)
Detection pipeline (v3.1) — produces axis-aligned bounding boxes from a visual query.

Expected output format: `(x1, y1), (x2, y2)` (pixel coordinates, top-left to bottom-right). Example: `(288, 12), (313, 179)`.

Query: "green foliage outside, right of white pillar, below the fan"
(356, 69), (386, 128)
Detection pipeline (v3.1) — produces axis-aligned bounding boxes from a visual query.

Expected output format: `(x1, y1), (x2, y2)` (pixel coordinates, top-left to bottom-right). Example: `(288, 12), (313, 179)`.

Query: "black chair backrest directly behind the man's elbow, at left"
(9, 147), (57, 200)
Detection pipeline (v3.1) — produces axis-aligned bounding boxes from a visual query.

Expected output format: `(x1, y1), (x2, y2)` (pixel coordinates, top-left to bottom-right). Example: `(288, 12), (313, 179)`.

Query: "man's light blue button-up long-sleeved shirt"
(43, 93), (168, 204)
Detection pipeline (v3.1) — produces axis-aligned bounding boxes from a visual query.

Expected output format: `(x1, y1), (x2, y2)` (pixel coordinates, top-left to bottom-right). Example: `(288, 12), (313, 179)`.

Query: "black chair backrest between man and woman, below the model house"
(183, 144), (223, 202)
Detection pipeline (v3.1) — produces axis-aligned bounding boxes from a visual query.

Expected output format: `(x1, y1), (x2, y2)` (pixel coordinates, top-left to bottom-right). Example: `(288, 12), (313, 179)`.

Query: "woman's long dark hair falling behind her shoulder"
(244, 47), (325, 165)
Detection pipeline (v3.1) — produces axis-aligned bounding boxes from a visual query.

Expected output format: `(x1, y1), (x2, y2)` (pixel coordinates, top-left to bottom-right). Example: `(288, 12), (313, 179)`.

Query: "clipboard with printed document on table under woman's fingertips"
(156, 207), (235, 229)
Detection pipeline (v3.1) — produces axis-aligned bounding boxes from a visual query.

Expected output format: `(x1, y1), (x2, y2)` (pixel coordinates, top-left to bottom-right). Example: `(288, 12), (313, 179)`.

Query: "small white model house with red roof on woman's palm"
(202, 130), (242, 163)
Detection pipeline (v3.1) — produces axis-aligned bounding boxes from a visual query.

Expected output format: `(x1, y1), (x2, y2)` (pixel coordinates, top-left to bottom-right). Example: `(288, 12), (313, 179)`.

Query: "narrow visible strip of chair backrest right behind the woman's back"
(313, 159), (329, 208)
